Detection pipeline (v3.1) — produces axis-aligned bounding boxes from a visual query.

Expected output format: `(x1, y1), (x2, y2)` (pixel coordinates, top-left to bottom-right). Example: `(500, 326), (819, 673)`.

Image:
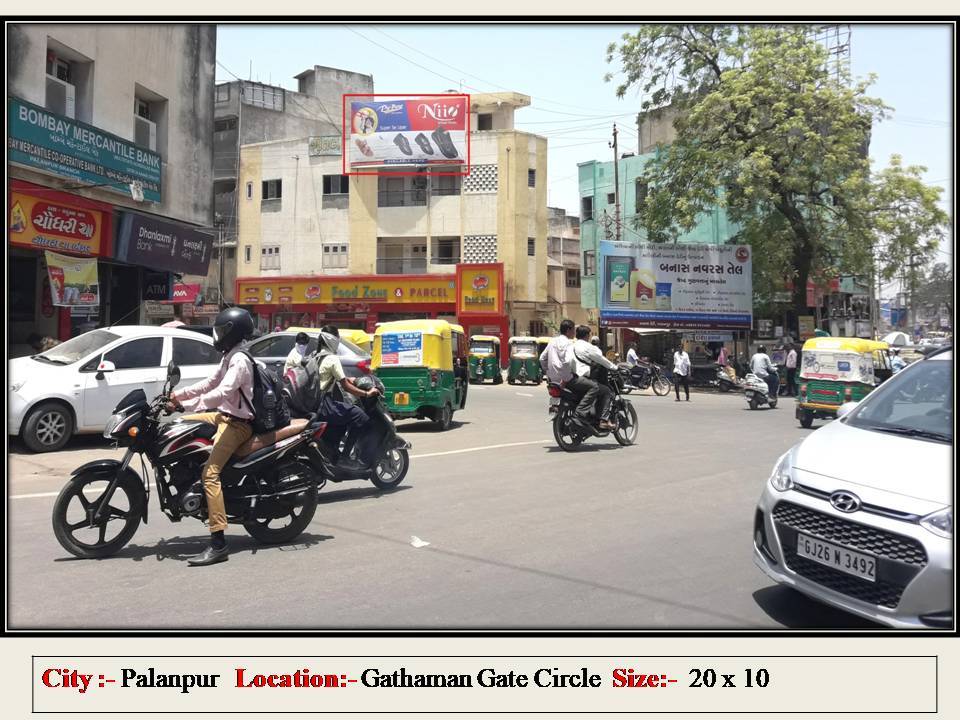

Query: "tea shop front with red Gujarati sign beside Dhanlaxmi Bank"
(7, 180), (113, 356)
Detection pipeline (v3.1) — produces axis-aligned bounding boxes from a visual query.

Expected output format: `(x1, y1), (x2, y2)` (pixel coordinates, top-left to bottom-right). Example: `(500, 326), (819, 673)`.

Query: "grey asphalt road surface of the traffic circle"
(7, 384), (872, 630)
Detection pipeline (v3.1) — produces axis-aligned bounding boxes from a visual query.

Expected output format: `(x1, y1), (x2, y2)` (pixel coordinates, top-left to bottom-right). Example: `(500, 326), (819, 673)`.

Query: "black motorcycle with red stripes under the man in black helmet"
(53, 363), (327, 558)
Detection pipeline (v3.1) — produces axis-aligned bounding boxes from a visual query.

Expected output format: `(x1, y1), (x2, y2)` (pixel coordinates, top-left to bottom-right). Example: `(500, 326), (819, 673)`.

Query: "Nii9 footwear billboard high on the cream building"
(343, 93), (470, 174)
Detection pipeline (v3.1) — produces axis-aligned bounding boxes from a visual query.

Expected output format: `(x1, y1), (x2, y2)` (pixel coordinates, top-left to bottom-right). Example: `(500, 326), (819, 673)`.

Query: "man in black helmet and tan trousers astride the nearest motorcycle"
(167, 307), (253, 565)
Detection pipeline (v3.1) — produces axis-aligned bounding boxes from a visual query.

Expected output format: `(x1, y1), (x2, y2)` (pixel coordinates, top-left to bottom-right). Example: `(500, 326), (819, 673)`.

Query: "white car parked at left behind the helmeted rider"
(7, 325), (221, 452)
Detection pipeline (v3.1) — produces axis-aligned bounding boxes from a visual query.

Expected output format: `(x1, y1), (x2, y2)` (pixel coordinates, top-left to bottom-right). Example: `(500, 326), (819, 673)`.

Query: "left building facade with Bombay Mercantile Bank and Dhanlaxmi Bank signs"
(7, 24), (216, 345)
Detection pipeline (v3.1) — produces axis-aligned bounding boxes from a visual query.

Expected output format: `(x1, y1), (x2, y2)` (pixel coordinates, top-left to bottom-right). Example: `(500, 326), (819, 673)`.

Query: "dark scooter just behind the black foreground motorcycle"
(321, 375), (413, 490)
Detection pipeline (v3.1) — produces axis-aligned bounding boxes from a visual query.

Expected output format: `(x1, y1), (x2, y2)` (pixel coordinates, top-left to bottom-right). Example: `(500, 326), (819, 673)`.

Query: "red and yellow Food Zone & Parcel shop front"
(236, 275), (457, 332)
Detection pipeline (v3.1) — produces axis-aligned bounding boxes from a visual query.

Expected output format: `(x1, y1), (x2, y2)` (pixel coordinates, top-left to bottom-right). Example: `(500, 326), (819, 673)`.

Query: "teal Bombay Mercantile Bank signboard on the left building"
(7, 97), (161, 202)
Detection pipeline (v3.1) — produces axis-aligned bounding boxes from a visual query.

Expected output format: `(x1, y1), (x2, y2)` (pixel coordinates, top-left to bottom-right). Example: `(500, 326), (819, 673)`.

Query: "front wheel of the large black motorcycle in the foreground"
(53, 473), (147, 559)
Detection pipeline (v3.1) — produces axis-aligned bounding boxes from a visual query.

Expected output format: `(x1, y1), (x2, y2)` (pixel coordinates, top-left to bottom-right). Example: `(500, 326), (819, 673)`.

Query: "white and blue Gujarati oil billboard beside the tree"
(598, 241), (753, 330)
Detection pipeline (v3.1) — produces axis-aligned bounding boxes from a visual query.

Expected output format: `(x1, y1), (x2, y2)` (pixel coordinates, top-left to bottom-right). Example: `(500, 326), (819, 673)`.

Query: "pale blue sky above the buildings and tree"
(217, 23), (953, 280)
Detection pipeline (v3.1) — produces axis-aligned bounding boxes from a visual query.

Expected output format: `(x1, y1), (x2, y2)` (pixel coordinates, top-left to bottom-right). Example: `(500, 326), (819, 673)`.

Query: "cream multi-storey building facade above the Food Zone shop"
(237, 93), (555, 334)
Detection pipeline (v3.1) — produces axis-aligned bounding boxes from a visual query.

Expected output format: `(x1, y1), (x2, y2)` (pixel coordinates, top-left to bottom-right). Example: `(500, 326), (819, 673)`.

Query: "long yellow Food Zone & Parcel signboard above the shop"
(237, 275), (457, 305)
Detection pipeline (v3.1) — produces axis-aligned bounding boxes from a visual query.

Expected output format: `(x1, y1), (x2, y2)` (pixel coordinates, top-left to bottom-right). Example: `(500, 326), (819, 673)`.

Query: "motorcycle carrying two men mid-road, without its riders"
(547, 372), (640, 452)
